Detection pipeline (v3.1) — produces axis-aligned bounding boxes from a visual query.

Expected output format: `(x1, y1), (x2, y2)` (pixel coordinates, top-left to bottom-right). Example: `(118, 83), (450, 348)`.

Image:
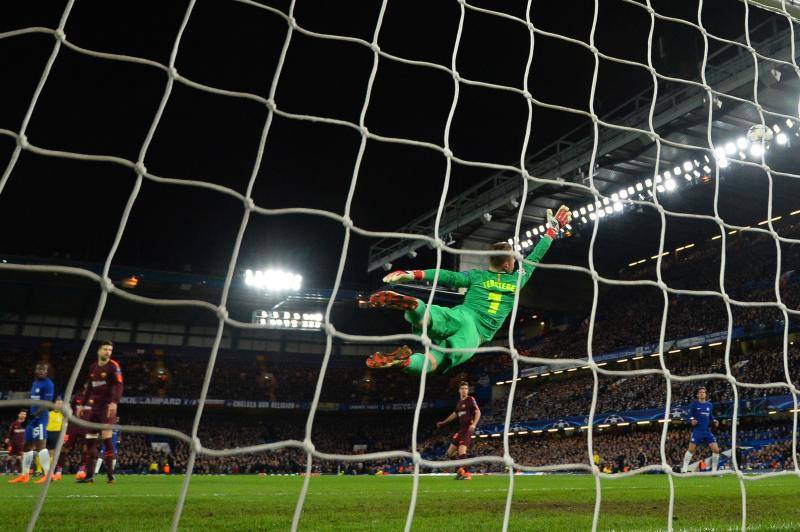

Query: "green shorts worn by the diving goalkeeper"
(406, 305), (482, 371)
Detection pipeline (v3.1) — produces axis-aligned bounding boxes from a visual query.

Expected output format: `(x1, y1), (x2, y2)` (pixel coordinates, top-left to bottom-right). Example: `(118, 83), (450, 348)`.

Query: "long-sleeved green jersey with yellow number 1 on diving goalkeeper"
(424, 238), (553, 342)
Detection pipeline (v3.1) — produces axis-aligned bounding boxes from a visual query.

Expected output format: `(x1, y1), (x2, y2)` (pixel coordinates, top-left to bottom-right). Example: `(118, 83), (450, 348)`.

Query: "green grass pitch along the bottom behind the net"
(0, 475), (800, 532)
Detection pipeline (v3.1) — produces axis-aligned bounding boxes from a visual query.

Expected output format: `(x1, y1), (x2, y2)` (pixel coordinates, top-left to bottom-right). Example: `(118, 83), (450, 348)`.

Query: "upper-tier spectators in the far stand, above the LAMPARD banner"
(0, 351), (484, 404)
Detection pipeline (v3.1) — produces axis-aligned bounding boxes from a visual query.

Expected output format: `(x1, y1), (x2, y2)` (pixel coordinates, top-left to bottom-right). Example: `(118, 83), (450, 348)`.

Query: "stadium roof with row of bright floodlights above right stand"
(368, 15), (800, 271)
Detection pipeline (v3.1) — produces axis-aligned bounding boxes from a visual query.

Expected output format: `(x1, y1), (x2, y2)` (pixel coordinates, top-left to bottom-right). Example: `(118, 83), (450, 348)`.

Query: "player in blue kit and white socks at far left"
(9, 362), (55, 484)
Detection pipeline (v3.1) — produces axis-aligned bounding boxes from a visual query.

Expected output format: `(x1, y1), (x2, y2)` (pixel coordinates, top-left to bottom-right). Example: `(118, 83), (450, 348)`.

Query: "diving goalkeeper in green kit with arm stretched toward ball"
(367, 205), (572, 375)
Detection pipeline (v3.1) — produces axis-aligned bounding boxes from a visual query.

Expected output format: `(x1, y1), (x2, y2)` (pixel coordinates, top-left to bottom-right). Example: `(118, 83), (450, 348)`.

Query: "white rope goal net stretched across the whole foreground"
(0, 0), (800, 530)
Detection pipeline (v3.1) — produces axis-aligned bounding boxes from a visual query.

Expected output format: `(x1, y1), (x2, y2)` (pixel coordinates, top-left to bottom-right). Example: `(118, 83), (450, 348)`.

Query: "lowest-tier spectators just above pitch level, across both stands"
(5, 411), (794, 474)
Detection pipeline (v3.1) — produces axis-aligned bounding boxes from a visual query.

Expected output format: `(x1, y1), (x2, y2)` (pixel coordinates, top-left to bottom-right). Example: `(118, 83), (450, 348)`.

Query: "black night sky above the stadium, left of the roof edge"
(0, 0), (755, 286)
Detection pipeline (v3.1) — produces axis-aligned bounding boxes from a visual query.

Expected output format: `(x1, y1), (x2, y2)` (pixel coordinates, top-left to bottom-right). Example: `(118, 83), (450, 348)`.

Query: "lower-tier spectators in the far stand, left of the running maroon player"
(2, 407), (438, 474)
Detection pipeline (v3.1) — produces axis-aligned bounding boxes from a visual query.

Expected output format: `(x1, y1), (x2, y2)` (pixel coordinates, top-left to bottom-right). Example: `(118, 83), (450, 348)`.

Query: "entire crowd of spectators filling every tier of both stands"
(0, 216), (800, 474)
